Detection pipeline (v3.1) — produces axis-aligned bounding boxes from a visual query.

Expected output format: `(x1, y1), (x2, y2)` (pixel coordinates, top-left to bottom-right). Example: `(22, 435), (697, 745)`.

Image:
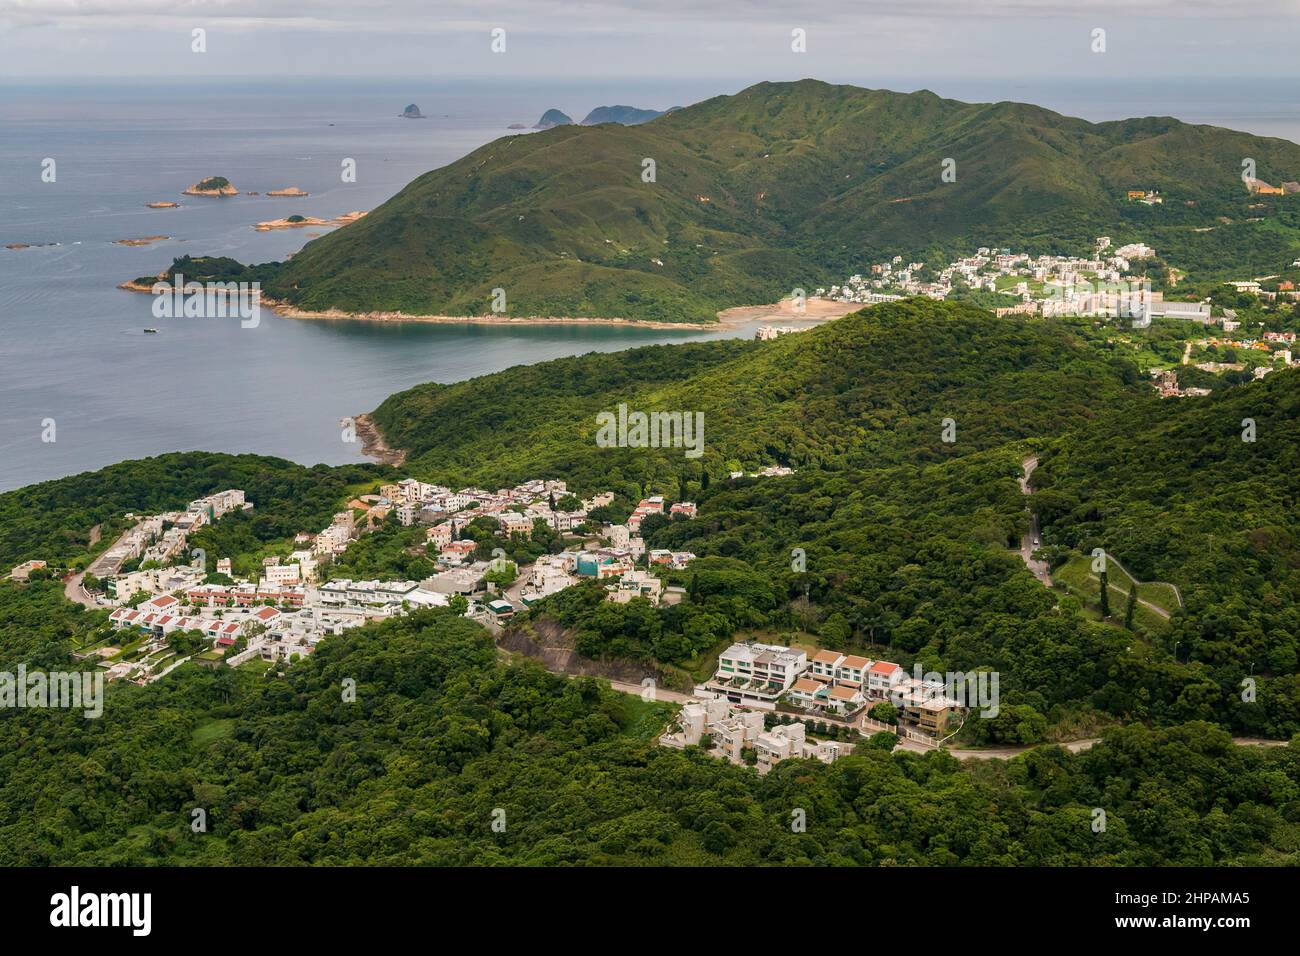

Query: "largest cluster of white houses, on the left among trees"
(10, 470), (712, 684)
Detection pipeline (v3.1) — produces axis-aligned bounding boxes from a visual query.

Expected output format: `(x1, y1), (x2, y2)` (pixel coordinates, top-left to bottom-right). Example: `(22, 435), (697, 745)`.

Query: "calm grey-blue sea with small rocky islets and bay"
(0, 75), (1300, 490)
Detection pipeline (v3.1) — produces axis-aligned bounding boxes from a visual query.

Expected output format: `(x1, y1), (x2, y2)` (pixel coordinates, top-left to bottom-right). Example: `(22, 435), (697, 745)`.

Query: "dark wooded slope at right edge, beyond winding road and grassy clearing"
(1034, 369), (1300, 732)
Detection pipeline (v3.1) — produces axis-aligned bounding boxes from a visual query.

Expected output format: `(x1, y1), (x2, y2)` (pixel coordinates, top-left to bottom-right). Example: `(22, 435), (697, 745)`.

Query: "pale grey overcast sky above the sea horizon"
(0, 0), (1300, 86)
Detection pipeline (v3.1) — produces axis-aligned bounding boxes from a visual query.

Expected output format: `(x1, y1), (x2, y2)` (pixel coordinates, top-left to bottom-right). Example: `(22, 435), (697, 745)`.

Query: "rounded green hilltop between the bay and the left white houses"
(374, 299), (1157, 489)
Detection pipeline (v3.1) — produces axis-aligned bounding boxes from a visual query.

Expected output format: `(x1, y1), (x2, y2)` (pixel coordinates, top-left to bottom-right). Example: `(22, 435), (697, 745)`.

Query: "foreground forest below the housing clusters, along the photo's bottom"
(0, 611), (1300, 866)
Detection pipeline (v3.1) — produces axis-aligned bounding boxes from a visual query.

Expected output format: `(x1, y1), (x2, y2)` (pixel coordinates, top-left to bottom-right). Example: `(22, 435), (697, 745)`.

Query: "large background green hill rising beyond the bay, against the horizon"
(202, 79), (1300, 321)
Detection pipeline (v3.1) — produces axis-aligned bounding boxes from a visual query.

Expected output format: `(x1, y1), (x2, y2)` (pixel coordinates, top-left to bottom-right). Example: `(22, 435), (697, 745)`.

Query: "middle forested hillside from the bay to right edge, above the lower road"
(364, 299), (1300, 740)
